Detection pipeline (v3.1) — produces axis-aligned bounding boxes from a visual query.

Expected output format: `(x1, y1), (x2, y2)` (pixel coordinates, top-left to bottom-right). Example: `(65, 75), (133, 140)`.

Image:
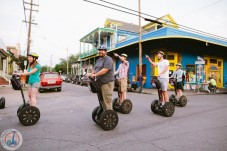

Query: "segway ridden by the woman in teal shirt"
(11, 75), (40, 126)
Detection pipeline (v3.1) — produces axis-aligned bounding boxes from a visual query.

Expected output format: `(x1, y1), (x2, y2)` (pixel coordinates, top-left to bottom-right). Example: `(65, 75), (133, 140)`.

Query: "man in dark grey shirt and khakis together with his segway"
(90, 46), (118, 130)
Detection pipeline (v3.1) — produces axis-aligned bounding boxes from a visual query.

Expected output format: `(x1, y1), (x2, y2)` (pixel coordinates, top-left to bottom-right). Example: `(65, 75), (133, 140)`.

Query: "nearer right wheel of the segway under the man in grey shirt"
(100, 110), (118, 131)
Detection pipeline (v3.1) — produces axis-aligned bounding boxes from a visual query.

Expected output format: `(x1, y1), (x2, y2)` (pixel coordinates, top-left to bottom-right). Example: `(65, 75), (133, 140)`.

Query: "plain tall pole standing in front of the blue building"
(138, 0), (143, 74)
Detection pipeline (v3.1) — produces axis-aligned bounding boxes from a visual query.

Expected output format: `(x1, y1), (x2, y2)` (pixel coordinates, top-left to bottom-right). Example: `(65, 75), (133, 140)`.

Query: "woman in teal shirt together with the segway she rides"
(11, 53), (41, 126)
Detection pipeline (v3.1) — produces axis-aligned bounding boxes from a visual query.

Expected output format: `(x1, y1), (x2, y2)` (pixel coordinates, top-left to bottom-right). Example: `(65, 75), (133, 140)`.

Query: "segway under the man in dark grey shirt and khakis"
(88, 77), (118, 131)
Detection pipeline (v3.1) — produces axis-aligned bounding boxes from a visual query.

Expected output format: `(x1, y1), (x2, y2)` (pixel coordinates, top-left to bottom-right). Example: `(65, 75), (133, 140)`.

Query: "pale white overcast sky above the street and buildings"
(0, 0), (227, 66)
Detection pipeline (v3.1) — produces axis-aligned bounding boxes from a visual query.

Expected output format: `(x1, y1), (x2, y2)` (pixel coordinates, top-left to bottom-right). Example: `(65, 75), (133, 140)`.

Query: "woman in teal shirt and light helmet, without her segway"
(21, 53), (41, 106)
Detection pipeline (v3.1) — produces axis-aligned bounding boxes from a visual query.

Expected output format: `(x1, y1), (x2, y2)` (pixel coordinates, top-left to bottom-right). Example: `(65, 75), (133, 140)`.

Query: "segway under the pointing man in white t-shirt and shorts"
(151, 77), (175, 117)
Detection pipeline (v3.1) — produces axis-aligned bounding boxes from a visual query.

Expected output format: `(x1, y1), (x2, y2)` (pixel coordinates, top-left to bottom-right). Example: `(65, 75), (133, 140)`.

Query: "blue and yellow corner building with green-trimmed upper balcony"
(80, 15), (227, 88)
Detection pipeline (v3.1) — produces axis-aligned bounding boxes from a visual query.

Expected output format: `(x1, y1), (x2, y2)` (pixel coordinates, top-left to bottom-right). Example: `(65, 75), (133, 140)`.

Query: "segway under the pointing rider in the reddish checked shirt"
(113, 79), (132, 114)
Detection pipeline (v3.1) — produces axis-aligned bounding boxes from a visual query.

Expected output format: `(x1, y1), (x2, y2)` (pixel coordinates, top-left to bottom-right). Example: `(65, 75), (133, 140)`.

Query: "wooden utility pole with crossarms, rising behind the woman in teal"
(23, 0), (39, 55)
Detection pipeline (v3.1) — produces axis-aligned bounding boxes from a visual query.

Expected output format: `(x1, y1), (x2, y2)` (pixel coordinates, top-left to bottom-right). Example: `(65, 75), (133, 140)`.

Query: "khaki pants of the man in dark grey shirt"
(101, 81), (114, 111)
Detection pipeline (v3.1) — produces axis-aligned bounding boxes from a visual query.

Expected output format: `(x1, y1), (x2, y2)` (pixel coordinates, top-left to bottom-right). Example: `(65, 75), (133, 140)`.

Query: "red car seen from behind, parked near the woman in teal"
(39, 72), (62, 93)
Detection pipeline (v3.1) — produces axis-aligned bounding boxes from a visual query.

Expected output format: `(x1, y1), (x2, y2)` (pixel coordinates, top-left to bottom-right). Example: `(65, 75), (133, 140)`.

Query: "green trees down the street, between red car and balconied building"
(54, 54), (79, 74)
